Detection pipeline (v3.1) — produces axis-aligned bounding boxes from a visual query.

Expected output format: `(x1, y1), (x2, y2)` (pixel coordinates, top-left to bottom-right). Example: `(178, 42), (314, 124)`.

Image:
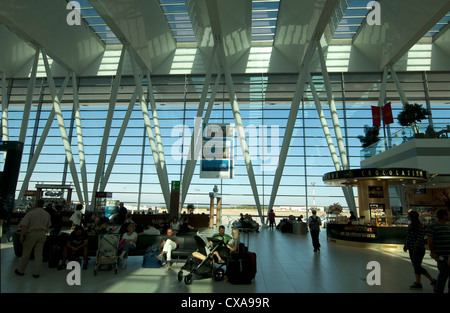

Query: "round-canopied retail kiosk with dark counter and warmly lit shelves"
(323, 168), (428, 247)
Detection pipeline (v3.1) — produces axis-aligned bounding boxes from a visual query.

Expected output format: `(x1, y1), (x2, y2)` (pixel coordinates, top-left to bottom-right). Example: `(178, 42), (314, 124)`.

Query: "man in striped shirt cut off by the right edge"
(427, 209), (450, 293)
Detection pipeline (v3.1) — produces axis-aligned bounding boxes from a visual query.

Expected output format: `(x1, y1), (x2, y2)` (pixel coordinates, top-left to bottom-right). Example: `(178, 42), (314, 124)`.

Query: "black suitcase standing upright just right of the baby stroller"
(226, 252), (256, 284)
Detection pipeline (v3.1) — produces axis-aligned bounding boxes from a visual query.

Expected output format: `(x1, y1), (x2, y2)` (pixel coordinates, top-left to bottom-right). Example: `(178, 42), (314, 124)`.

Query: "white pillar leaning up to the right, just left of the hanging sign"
(181, 45), (220, 207)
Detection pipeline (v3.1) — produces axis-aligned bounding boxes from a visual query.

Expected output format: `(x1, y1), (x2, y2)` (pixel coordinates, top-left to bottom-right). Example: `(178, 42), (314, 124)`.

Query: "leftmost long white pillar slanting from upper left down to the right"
(42, 49), (83, 202)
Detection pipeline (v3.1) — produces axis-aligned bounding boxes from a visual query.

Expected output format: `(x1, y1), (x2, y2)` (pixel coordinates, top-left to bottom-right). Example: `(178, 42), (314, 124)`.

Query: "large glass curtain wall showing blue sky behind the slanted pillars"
(0, 72), (450, 213)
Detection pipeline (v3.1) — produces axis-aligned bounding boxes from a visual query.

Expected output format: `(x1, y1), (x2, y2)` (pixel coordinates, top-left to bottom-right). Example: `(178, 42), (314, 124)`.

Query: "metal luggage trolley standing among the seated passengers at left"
(94, 234), (120, 275)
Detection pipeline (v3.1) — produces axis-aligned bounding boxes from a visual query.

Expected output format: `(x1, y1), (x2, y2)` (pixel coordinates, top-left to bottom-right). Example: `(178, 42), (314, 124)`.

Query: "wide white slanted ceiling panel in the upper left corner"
(0, 0), (105, 73)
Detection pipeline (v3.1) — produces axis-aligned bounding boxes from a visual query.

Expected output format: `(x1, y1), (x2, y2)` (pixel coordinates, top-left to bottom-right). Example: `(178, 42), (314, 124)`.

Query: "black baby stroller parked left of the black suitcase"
(178, 235), (225, 285)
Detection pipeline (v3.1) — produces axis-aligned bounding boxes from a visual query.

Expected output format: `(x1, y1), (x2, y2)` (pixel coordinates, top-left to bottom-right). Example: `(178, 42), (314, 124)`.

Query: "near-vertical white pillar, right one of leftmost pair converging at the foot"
(72, 72), (89, 202)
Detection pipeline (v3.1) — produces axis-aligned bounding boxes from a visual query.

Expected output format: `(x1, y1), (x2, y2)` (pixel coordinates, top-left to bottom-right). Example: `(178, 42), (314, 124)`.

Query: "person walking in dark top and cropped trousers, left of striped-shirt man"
(403, 210), (436, 290)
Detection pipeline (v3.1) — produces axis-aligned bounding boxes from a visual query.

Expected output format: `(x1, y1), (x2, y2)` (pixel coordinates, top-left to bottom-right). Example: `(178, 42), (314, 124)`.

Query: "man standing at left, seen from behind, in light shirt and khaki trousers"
(15, 199), (51, 278)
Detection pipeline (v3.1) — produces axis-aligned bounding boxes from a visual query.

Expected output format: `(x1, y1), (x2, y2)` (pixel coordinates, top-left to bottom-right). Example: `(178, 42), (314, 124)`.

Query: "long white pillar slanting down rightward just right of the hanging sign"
(214, 38), (264, 224)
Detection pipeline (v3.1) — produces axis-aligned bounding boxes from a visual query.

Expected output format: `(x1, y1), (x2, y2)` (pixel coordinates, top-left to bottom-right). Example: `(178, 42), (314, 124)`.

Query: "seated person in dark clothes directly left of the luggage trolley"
(58, 225), (88, 270)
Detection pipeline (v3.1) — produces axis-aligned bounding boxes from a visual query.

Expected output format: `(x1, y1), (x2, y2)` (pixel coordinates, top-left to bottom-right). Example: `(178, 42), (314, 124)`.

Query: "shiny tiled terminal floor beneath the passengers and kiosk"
(1, 224), (437, 294)
